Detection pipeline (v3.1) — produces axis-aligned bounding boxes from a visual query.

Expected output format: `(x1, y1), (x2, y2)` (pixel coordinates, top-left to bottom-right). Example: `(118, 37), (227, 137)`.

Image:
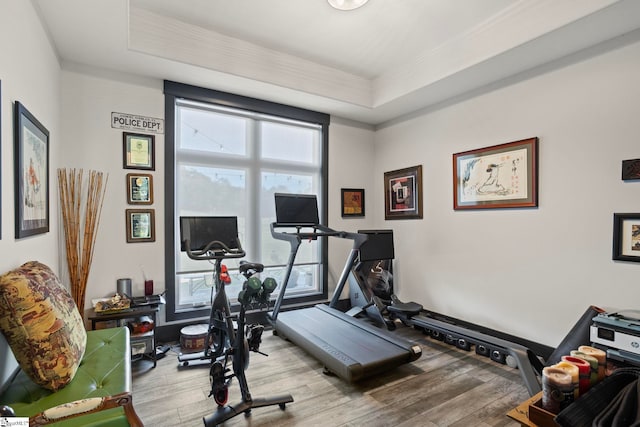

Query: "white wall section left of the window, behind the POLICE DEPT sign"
(58, 67), (165, 317)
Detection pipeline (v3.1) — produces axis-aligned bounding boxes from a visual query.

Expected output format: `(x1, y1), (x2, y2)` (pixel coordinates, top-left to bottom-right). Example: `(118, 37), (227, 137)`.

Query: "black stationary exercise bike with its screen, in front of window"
(181, 217), (293, 427)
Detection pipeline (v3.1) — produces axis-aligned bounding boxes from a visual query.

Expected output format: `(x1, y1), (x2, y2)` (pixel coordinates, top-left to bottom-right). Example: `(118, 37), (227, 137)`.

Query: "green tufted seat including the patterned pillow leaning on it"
(0, 261), (143, 427)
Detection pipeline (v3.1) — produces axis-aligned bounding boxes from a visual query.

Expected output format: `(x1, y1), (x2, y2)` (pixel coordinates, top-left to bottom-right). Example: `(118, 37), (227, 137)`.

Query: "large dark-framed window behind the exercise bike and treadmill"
(165, 82), (328, 320)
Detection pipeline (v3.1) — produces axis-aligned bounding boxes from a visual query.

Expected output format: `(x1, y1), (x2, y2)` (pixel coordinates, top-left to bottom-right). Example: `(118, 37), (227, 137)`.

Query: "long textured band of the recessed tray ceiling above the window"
(128, 6), (372, 107)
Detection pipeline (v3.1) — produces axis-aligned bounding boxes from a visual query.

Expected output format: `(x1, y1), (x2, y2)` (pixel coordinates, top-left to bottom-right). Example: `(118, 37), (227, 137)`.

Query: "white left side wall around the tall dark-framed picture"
(0, 0), (60, 383)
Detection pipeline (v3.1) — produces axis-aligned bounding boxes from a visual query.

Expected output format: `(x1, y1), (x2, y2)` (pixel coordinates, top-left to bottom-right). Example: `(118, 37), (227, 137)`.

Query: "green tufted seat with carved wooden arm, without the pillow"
(0, 327), (143, 427)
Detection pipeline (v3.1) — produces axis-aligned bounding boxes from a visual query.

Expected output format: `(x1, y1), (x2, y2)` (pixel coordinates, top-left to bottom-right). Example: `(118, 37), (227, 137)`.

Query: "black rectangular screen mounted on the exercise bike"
(180, 216), (239, 252)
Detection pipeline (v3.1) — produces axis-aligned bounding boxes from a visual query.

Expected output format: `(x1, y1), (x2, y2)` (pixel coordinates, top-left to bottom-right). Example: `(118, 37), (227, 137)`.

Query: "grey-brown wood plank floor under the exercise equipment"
(133, 325), (529, 427)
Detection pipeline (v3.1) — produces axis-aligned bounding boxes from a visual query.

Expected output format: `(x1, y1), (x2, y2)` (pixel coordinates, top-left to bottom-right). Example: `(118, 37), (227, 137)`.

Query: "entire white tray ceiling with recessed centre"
(32, 0), (640, 125)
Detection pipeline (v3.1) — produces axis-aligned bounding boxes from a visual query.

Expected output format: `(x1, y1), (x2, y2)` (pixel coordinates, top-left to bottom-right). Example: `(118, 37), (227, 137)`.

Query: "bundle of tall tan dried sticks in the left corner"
(58, 169), (109, 315)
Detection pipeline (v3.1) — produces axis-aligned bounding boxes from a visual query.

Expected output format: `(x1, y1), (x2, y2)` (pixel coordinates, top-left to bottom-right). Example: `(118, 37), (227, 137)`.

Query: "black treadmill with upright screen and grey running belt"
(267, 193), (422, 382)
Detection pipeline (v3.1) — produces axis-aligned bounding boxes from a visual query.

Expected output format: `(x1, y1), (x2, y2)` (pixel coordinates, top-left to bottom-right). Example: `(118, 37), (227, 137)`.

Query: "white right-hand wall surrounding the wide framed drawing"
(375, 36), (640, 346)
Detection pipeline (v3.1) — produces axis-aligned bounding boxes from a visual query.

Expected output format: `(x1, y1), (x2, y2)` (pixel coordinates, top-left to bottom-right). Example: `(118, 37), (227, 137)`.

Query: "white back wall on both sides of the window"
(58, 71), (374, 324)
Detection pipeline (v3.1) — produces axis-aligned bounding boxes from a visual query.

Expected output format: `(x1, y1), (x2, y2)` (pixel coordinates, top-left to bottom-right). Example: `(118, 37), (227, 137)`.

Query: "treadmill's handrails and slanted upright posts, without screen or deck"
(268, 222), (368, 322)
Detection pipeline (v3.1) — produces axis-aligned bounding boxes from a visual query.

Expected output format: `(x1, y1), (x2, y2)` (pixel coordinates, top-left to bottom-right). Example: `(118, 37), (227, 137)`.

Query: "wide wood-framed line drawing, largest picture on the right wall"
(453, 138), (538, 210)
